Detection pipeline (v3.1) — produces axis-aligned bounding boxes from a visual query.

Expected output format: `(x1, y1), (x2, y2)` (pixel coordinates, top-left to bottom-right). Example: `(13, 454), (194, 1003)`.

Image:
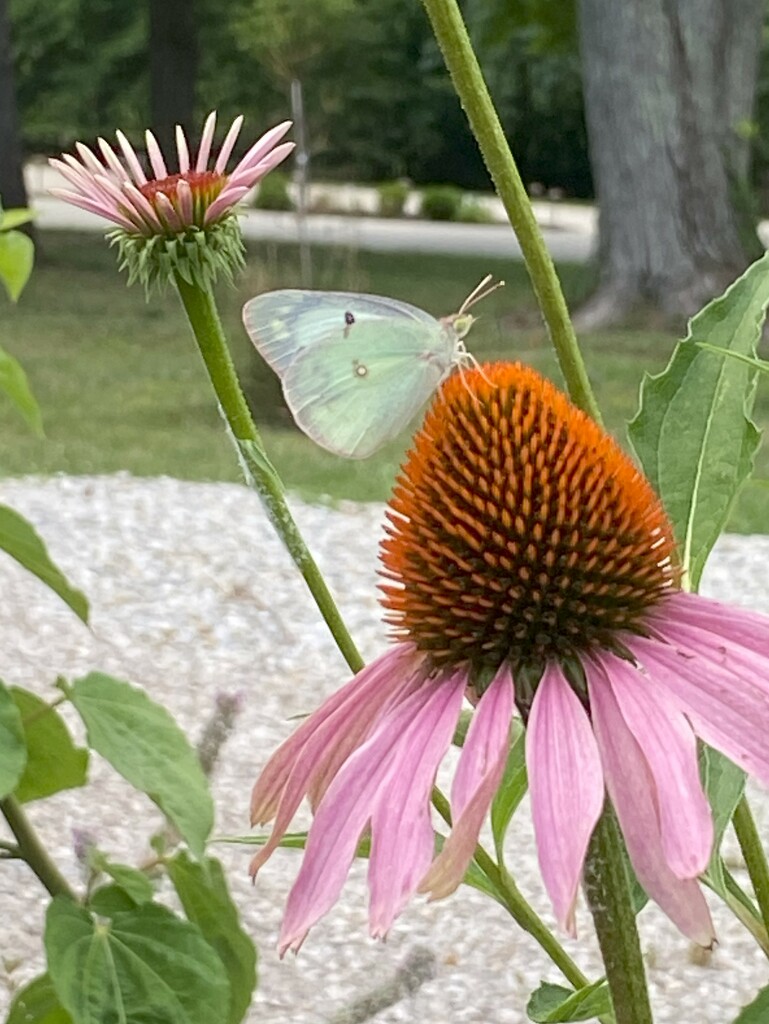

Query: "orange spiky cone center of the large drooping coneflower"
(381, 362), (677, 670)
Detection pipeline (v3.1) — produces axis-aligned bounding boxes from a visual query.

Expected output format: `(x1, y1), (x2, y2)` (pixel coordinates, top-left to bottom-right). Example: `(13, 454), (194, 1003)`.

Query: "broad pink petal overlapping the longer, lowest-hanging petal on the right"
(591, 652), (713, 879)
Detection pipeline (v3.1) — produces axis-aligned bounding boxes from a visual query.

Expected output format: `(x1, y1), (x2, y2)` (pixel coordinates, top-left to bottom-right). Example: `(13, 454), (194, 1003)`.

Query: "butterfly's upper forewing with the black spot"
(243, 288), (437, 377)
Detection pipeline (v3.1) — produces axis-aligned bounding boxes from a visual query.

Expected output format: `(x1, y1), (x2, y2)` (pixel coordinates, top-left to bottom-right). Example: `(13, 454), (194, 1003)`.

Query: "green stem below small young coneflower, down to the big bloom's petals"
(175, 274), (364, 672)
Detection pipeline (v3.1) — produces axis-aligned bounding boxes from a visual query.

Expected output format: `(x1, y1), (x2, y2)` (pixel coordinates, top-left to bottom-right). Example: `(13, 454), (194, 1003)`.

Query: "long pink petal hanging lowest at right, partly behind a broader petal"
(585, 657), (715, 946)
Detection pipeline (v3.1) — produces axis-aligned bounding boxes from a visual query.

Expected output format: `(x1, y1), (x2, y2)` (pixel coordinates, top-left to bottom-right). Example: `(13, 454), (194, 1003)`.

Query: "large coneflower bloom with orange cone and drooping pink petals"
(252, 364), (769, 953)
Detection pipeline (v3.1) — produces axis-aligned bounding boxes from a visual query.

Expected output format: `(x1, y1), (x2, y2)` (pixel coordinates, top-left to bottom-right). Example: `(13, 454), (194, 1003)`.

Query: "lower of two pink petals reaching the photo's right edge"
(626, 637), (769, 785)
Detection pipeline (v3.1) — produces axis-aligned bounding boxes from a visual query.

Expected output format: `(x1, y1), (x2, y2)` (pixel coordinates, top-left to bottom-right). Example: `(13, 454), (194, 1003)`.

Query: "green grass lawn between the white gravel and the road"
(0, 232), (769, 532)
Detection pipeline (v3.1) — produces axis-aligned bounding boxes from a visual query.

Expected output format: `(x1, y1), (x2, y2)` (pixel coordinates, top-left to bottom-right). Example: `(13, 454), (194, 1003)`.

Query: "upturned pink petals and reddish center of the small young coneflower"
(50, 113), (294, 238)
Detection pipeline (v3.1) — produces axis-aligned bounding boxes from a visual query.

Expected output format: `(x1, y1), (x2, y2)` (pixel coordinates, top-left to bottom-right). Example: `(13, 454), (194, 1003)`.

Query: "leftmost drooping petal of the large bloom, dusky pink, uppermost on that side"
(251, 644), (420, 825)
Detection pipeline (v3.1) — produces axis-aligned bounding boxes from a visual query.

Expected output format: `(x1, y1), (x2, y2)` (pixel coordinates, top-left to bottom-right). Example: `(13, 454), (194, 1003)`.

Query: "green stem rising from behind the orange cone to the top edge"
(423, 0), (601, 423)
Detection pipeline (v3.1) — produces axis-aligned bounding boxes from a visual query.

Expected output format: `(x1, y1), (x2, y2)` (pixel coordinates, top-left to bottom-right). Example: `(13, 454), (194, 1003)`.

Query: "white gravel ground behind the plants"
(0, 475), (769, 1024)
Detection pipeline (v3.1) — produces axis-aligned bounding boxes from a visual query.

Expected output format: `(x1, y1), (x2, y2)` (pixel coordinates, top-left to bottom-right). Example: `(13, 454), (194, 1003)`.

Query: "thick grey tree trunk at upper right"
(576, 0), (764, 327)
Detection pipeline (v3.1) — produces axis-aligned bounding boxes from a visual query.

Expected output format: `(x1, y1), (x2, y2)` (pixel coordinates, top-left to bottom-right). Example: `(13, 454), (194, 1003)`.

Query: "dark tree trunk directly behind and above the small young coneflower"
(149, 0), (198, 157)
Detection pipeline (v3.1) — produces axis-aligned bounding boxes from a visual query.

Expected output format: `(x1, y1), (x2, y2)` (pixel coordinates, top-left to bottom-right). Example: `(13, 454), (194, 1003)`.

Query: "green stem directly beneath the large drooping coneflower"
(584, 802), (651, 1024)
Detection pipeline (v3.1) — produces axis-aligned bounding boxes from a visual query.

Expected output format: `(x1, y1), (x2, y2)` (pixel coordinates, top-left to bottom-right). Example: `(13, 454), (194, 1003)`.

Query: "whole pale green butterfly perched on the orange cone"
(243, 274), (504, 459)
